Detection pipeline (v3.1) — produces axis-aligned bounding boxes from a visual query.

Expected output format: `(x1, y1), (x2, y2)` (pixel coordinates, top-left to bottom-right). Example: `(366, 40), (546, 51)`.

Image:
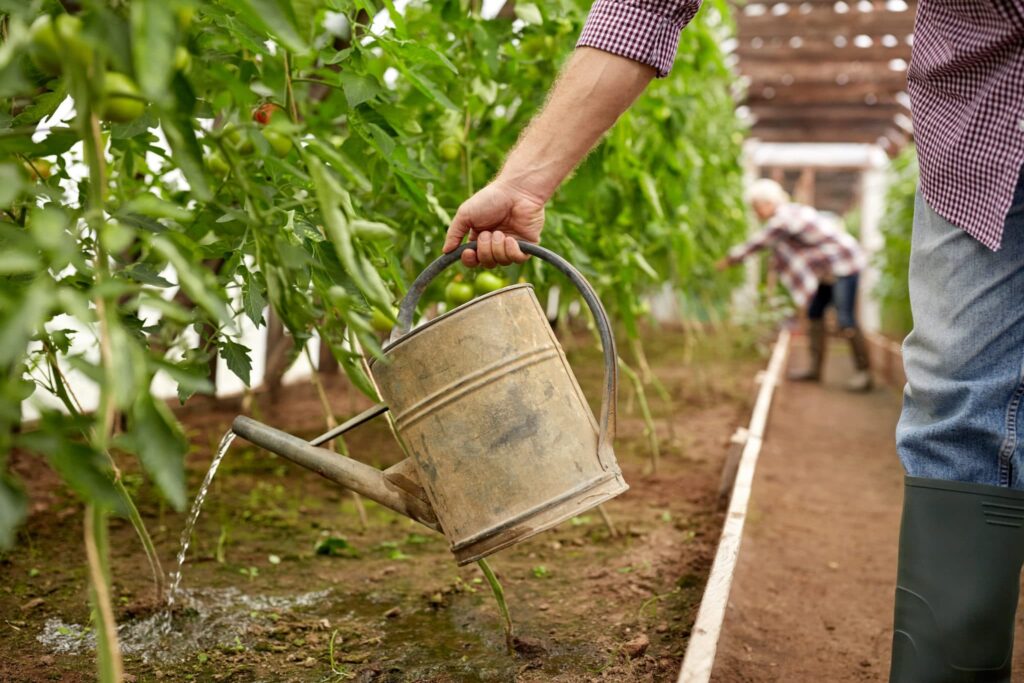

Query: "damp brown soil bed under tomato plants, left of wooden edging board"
(0, 325), (763, 682)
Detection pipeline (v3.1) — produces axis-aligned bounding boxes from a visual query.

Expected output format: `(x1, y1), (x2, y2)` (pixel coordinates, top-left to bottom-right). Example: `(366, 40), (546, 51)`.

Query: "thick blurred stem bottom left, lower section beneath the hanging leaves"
(85, 505), (124, 683)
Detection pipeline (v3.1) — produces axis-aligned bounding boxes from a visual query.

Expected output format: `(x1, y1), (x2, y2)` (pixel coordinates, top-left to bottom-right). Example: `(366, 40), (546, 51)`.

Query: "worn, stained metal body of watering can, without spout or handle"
(372, 285), (627, 562)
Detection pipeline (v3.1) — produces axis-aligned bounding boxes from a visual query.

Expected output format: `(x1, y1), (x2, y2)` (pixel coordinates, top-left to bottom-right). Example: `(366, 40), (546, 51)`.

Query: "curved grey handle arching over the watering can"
(388, 240), (618, 450)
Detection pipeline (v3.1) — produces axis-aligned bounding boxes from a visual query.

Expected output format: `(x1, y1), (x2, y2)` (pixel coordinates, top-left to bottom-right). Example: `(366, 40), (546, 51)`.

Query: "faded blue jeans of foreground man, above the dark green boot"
(896, 169), (1024, 488)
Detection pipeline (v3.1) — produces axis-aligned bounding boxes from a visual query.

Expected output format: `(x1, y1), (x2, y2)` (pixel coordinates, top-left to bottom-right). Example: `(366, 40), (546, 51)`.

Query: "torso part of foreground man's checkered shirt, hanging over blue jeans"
(907, 0), (1024, 250)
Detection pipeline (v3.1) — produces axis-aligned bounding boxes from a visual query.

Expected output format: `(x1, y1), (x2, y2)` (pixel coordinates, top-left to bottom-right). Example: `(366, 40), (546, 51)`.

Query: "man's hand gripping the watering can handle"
(444, 180), (544, 268)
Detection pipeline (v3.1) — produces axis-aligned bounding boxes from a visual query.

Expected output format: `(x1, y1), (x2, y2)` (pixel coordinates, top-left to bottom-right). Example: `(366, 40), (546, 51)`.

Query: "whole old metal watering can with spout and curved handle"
(232, 242), (629, 565)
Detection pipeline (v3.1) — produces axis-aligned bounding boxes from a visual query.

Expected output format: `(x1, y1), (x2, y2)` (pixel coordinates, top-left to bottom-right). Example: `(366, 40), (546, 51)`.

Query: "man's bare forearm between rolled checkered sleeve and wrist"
(498, 47), (655, 202)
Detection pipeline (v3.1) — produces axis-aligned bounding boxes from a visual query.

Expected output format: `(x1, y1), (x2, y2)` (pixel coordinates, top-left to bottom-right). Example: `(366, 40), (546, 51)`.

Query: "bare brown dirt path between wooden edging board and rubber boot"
(712, 341), (902, 683)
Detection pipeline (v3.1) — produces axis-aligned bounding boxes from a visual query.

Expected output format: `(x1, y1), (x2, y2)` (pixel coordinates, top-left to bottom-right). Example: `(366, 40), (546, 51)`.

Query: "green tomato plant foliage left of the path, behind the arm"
(0, 0), (745, 561)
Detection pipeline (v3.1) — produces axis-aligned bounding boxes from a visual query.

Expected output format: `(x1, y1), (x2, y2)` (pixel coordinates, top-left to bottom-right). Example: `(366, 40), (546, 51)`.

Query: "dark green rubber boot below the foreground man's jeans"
(889, 477), (1024, 683)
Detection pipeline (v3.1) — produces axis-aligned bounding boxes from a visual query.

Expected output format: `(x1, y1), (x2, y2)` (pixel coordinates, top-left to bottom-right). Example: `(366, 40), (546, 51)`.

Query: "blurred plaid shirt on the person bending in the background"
(728, 204), (867, 307)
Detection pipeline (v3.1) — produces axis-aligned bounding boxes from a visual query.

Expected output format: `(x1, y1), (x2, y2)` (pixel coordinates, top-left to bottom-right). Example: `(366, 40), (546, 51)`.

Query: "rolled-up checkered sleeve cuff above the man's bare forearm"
(577, 0), (701, 77)
